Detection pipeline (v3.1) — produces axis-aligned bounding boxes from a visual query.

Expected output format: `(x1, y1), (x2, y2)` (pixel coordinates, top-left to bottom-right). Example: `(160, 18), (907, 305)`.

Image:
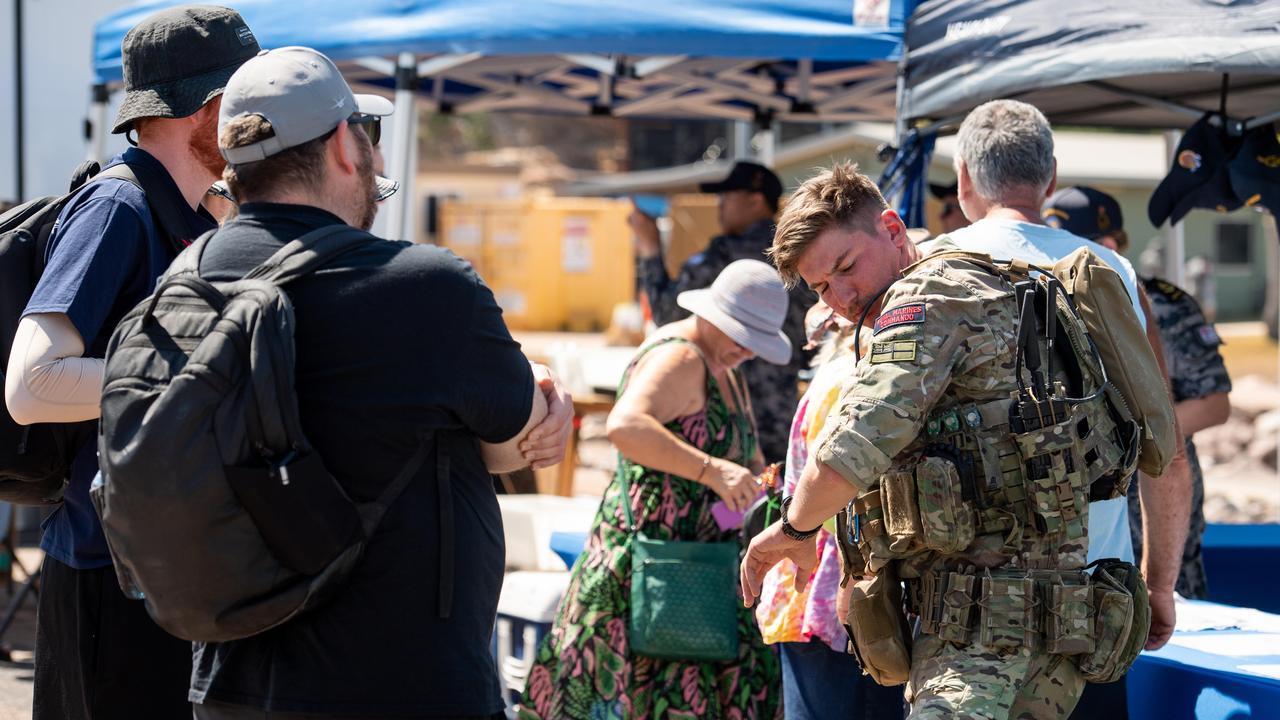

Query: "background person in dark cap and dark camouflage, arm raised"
(631, 163), (817, 462)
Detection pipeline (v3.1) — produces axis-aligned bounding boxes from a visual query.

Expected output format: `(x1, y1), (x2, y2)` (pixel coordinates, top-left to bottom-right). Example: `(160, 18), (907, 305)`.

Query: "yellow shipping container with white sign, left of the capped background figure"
(440, 197), (635, 332)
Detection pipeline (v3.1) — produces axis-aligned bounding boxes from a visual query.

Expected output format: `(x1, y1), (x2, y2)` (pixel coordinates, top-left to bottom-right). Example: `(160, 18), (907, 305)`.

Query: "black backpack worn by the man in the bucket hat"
(0, 160), (192, 505)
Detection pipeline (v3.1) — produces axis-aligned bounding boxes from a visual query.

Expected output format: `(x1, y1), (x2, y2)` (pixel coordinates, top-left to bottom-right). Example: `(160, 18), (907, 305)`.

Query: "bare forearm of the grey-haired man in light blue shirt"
(1138, 445), (1192, 592)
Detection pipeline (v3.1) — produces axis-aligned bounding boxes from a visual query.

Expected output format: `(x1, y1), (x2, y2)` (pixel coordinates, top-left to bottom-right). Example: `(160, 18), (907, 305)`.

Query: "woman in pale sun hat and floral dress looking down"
(520, 260), (791, 720)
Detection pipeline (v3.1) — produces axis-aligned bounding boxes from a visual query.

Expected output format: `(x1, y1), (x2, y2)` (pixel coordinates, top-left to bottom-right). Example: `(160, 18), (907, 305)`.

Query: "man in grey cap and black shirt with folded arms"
(191, 47), (572, 720)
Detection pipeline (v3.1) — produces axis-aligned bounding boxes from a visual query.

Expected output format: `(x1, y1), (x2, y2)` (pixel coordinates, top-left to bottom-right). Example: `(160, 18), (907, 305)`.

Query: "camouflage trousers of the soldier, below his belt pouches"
(906, 633), (1084, 720)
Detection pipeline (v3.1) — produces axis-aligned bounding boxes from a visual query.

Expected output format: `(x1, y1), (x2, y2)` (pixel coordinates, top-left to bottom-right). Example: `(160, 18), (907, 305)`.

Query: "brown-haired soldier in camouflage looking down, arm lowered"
(742, 165), (1126, 719)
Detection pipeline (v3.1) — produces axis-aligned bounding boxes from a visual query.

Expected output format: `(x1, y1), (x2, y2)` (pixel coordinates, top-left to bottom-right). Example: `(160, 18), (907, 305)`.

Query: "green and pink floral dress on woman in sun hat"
(520, 337), (782, 720)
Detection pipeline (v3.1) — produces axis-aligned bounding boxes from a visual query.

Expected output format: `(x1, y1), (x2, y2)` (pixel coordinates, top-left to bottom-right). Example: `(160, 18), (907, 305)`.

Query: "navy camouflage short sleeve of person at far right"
(1142, 278), (1231, 402)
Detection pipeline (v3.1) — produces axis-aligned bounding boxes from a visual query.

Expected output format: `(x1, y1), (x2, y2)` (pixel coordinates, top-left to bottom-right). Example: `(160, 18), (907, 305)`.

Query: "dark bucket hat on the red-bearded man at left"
(111, 5), (259, 133)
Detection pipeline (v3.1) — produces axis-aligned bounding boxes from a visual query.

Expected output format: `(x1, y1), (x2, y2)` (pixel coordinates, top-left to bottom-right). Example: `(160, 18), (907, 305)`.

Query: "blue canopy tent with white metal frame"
(93, 0), (916, 237)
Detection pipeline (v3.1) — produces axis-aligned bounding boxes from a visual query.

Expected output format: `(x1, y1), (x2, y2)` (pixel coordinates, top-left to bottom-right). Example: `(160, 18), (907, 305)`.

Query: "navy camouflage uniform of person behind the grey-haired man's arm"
(1129, 278), (1231, 600)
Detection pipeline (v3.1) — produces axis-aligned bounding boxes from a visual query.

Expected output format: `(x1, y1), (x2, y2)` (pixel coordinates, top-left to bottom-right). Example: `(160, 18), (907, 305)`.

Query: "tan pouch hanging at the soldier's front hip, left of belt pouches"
(845, 562), (911, 687)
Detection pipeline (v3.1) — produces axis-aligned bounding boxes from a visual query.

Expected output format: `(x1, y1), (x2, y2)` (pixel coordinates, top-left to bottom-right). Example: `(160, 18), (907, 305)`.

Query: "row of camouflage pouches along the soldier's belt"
(906, 560), (1151, 683)
